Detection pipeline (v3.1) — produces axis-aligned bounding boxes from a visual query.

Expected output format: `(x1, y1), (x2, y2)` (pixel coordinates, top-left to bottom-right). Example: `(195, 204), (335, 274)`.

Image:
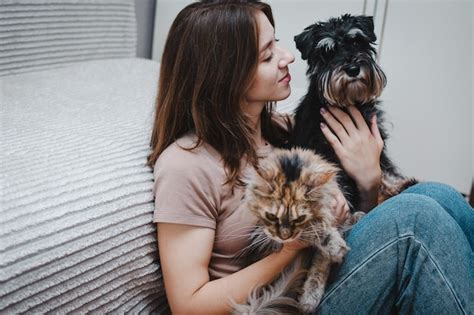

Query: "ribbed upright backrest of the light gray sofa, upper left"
(0, 0), (136, 76)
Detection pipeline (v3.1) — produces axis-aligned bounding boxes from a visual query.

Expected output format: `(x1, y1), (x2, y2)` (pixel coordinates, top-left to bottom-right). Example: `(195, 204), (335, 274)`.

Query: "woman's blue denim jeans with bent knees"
(316, 183), (474, 315)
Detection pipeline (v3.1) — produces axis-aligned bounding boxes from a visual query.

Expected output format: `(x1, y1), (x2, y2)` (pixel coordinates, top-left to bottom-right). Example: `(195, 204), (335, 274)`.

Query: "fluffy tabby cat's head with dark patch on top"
(245, 149), (339, 242)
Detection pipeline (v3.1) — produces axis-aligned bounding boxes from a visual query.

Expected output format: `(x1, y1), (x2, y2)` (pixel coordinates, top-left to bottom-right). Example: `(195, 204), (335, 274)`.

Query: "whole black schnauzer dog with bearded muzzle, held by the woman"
(290, 14), (417, 210)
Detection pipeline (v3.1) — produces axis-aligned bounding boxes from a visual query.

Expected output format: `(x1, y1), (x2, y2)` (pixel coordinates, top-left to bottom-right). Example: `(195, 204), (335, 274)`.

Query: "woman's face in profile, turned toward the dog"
(247, 12), (295, 103)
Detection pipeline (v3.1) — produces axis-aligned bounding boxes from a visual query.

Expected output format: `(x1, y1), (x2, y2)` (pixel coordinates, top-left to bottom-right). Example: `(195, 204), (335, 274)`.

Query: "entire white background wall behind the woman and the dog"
(153, 0), (474, 193)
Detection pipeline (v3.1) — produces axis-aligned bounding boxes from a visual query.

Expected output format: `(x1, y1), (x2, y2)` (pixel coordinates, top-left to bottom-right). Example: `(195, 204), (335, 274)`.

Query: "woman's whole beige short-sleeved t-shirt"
(153, 134), (273, 280)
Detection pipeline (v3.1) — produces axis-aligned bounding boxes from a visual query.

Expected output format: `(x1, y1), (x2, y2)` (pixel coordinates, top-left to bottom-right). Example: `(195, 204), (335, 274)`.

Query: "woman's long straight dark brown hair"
(148, 0), (287, 183)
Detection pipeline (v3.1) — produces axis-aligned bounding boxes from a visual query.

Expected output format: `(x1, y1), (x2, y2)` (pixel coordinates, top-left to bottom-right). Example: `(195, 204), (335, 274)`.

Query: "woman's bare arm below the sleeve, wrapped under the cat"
(158, 223), (299, 314)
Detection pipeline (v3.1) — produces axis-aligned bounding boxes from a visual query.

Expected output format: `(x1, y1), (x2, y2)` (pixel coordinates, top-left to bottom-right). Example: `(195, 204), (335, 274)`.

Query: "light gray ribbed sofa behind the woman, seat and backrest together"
(0, 0), (168, 314)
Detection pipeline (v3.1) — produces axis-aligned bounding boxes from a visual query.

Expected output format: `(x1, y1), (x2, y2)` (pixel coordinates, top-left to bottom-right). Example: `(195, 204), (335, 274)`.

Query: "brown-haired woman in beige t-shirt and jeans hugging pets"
(149, 1), (474, 314)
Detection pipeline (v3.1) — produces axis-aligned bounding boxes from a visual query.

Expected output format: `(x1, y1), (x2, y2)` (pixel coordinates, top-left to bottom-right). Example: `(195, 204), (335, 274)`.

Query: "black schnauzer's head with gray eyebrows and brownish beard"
(294, 14), (386, 107)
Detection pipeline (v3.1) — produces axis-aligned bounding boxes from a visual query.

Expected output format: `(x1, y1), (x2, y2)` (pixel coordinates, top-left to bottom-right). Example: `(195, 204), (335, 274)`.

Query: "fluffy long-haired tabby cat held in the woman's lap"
(234, 149), (363, 314)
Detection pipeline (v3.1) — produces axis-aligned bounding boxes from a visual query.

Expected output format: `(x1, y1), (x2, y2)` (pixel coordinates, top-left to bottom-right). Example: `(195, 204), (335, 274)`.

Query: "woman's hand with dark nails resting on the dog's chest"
(321, 106), (384, 193)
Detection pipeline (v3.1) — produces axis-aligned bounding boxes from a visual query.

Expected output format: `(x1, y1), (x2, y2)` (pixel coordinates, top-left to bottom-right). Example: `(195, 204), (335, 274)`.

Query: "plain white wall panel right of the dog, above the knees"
(381, 1), (474, 193)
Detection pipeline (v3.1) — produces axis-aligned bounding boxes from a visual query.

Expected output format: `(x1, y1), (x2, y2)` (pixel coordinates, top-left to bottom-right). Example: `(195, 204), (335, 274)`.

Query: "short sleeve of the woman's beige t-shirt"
(153, 145), (220, 229)
